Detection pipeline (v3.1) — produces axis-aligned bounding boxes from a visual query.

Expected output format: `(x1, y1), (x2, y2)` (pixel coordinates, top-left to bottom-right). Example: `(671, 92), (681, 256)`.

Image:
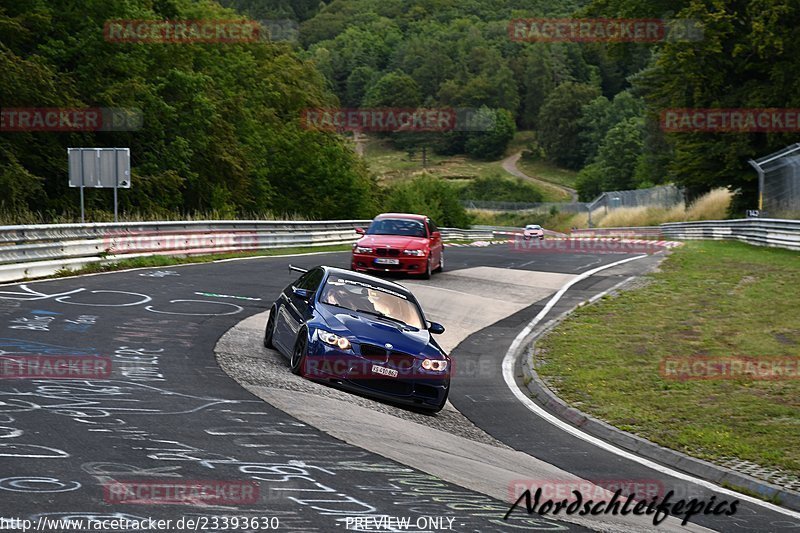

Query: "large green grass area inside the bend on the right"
(537, 241), (800, 475)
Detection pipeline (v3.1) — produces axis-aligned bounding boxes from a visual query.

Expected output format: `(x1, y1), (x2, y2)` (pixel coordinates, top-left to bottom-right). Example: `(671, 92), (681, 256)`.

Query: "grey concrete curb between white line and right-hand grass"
(515, 286), (800, 511)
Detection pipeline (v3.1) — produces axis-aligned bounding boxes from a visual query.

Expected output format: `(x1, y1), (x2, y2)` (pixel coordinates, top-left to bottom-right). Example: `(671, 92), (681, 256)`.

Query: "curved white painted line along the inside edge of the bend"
(503, 255), (800, 519)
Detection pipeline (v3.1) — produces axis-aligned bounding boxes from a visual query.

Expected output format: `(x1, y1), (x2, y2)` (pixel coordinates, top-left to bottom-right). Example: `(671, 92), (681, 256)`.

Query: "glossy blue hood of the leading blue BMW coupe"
(320, 304), (439, 355)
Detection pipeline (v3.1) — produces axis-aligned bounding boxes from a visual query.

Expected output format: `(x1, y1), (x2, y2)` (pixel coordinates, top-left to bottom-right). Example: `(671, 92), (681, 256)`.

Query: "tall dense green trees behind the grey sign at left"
(0, 0), (378, 220)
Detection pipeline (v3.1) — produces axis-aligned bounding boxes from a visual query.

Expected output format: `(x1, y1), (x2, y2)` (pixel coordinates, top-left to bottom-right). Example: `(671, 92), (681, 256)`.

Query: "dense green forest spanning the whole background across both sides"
(0, 0), (800, 217)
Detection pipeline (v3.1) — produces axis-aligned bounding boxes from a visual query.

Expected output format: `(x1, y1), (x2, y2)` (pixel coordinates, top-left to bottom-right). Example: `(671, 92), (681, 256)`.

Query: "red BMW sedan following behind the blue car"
(351, 213), (444, 279)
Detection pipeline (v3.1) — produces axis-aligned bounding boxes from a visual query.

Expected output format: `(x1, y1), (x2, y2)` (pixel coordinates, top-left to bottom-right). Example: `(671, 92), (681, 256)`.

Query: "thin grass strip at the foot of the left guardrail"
(52, 244), (352, 278)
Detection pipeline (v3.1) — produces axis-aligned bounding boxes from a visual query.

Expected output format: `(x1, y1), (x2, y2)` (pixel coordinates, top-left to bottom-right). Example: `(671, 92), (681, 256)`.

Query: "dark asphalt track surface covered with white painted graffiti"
(0, 246), (798, 532)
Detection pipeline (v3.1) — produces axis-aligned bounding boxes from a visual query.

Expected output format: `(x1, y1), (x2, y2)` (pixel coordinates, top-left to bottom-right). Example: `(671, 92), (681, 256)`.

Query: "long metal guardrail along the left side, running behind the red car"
(0, 220), (493, 282)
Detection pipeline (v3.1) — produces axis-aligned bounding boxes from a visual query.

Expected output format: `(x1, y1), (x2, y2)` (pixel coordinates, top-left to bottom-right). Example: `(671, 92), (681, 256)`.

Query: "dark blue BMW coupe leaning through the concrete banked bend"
(264, 266), (451, 413)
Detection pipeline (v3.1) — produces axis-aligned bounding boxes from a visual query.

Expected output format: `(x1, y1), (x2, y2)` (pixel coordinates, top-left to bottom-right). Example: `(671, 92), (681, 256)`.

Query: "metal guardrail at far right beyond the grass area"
(660, 218), (800, 251)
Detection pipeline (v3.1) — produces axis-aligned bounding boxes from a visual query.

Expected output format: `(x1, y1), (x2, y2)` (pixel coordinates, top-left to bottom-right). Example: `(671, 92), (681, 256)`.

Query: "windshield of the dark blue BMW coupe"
(320, 276), (423, 329)
